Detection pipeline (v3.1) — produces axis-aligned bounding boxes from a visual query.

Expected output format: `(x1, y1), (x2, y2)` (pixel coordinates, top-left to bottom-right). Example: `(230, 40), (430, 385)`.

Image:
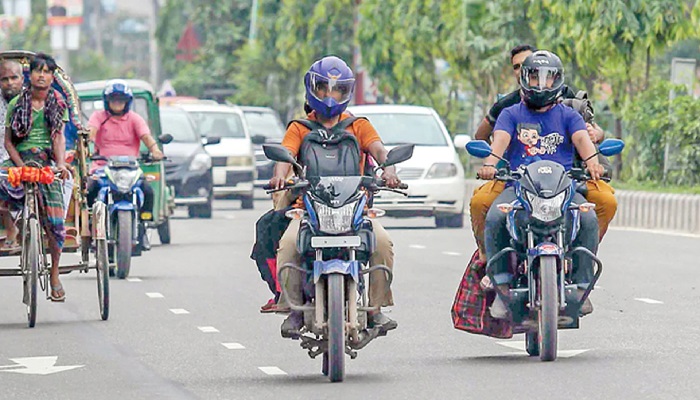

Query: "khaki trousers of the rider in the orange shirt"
(277, 220), (394, 307)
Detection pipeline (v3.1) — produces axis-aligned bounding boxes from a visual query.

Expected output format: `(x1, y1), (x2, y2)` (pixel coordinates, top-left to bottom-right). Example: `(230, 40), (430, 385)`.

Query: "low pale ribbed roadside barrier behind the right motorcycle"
(465, 179), (700, 235)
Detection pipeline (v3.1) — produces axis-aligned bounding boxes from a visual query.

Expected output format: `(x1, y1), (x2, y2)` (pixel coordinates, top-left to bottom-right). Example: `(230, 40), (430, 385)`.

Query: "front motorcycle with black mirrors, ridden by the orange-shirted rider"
(263, 144), (413, 382)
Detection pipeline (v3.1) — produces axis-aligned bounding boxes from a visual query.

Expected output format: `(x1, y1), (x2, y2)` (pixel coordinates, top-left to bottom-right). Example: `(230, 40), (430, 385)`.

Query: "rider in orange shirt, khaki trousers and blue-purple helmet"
(270, 56), (400, 337)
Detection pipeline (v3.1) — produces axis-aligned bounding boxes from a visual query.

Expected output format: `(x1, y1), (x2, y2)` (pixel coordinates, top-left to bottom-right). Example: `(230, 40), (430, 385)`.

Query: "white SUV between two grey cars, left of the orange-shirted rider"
(178, 103), (257, 209)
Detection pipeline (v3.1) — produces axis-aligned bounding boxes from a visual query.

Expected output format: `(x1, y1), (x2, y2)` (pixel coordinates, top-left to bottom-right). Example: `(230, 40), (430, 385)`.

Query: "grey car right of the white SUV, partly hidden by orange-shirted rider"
(241, 106), (285, 187)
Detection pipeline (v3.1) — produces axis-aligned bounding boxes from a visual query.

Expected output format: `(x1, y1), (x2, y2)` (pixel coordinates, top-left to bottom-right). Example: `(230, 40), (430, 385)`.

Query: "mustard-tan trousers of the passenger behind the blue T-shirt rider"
(469, 180), (617, 261)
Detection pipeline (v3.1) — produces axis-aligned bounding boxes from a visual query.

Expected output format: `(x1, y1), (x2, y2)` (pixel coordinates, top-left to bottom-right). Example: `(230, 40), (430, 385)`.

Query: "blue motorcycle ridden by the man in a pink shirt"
(92, 156), (159, 279)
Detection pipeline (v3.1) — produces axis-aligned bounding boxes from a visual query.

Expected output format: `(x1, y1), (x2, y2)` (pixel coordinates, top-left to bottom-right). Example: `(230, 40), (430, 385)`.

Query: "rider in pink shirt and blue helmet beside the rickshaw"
(88, 79), (163, 220)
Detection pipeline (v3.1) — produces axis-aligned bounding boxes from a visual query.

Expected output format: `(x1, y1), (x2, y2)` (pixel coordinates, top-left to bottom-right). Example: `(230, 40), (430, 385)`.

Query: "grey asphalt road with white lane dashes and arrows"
(0, 193), (700, 400)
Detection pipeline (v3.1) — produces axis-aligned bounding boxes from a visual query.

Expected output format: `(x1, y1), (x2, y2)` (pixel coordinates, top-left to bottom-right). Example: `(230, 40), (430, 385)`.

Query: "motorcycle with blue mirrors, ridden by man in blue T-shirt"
(466, 139), (624, 361)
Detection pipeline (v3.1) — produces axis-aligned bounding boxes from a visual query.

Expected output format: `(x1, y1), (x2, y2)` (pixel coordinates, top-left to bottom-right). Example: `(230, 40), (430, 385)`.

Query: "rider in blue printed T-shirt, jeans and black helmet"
(478, 51), (603, 318)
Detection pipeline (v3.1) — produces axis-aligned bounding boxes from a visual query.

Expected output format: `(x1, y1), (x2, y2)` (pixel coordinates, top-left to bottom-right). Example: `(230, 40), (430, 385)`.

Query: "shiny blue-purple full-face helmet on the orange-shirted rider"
(304, 56), (355, 118)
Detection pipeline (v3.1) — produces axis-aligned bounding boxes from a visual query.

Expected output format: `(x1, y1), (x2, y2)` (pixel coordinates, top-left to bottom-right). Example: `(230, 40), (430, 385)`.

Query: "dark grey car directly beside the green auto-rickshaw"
(160, 106), (221, 218)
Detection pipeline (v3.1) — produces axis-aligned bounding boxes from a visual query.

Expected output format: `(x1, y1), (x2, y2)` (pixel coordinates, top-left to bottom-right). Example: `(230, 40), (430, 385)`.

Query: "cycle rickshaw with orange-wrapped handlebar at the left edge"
(0, 50), (110, 328)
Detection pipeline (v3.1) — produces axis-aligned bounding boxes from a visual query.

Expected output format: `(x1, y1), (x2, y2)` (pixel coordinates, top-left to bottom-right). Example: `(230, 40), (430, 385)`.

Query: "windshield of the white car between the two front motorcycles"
(358, 113), (447, 146)
